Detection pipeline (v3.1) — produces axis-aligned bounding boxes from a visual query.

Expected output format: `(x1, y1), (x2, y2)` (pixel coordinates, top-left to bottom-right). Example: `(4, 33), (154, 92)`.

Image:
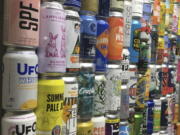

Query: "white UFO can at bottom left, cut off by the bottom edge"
(1, 112), (36, 135)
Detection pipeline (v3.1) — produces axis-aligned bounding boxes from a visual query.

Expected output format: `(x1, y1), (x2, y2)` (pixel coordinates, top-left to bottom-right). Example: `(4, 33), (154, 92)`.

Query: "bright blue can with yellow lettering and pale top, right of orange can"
(129, 18), (141, 64)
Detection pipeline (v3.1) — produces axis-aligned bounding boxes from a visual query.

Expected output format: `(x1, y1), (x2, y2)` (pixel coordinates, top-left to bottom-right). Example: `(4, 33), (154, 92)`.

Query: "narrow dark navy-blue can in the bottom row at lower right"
(146, 100), (154, 134)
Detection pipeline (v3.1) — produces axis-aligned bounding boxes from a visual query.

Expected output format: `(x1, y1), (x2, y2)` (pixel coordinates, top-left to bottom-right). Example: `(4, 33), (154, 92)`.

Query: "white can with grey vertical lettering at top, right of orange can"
(123, 0), (132, 47)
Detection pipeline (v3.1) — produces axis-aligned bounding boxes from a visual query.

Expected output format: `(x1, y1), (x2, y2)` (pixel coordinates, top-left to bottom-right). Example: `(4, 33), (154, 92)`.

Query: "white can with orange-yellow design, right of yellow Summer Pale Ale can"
(62, 75), (78, 135)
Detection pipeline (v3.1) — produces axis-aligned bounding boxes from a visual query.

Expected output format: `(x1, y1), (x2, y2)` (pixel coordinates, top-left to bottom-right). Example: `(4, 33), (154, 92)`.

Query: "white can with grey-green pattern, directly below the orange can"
(105, 64), (122, 111)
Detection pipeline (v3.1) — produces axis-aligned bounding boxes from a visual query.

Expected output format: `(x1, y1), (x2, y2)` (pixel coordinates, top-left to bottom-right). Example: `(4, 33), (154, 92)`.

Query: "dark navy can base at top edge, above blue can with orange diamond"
(99, 0), (110, 17)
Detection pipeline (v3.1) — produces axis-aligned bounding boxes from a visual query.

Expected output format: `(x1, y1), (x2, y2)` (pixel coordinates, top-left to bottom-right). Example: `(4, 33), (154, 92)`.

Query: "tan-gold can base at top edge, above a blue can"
(81, 0), (99, 14)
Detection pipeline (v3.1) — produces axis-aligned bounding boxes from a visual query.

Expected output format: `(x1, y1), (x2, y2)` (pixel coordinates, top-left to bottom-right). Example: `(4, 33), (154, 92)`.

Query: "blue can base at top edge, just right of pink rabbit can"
(64, 0), (81, 10)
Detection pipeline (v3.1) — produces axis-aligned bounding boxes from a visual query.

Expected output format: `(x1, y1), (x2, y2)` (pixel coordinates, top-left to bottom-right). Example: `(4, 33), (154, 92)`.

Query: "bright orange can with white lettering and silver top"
(108, 11), (124, 61)
